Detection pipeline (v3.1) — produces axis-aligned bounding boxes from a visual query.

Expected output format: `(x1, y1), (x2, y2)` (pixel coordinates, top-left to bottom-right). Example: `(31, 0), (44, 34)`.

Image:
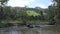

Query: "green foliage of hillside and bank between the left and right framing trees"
(1, 7), (49, 26)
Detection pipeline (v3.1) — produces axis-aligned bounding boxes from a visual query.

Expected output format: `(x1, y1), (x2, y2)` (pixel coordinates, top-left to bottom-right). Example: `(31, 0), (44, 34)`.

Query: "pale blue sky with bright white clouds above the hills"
(7, 0), (52, 8)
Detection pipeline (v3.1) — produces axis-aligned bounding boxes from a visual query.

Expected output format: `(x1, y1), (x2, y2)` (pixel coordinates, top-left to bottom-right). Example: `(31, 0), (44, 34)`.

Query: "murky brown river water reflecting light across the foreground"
(0, 26), (60, 34)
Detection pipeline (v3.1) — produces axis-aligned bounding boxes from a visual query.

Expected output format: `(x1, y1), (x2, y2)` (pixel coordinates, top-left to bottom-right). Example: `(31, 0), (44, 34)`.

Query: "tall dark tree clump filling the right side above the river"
(49, 0), (60, 24)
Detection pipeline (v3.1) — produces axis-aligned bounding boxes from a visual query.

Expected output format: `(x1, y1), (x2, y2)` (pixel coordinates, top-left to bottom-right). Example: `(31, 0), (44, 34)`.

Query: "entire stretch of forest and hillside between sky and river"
(0, 0), (60, 27)
